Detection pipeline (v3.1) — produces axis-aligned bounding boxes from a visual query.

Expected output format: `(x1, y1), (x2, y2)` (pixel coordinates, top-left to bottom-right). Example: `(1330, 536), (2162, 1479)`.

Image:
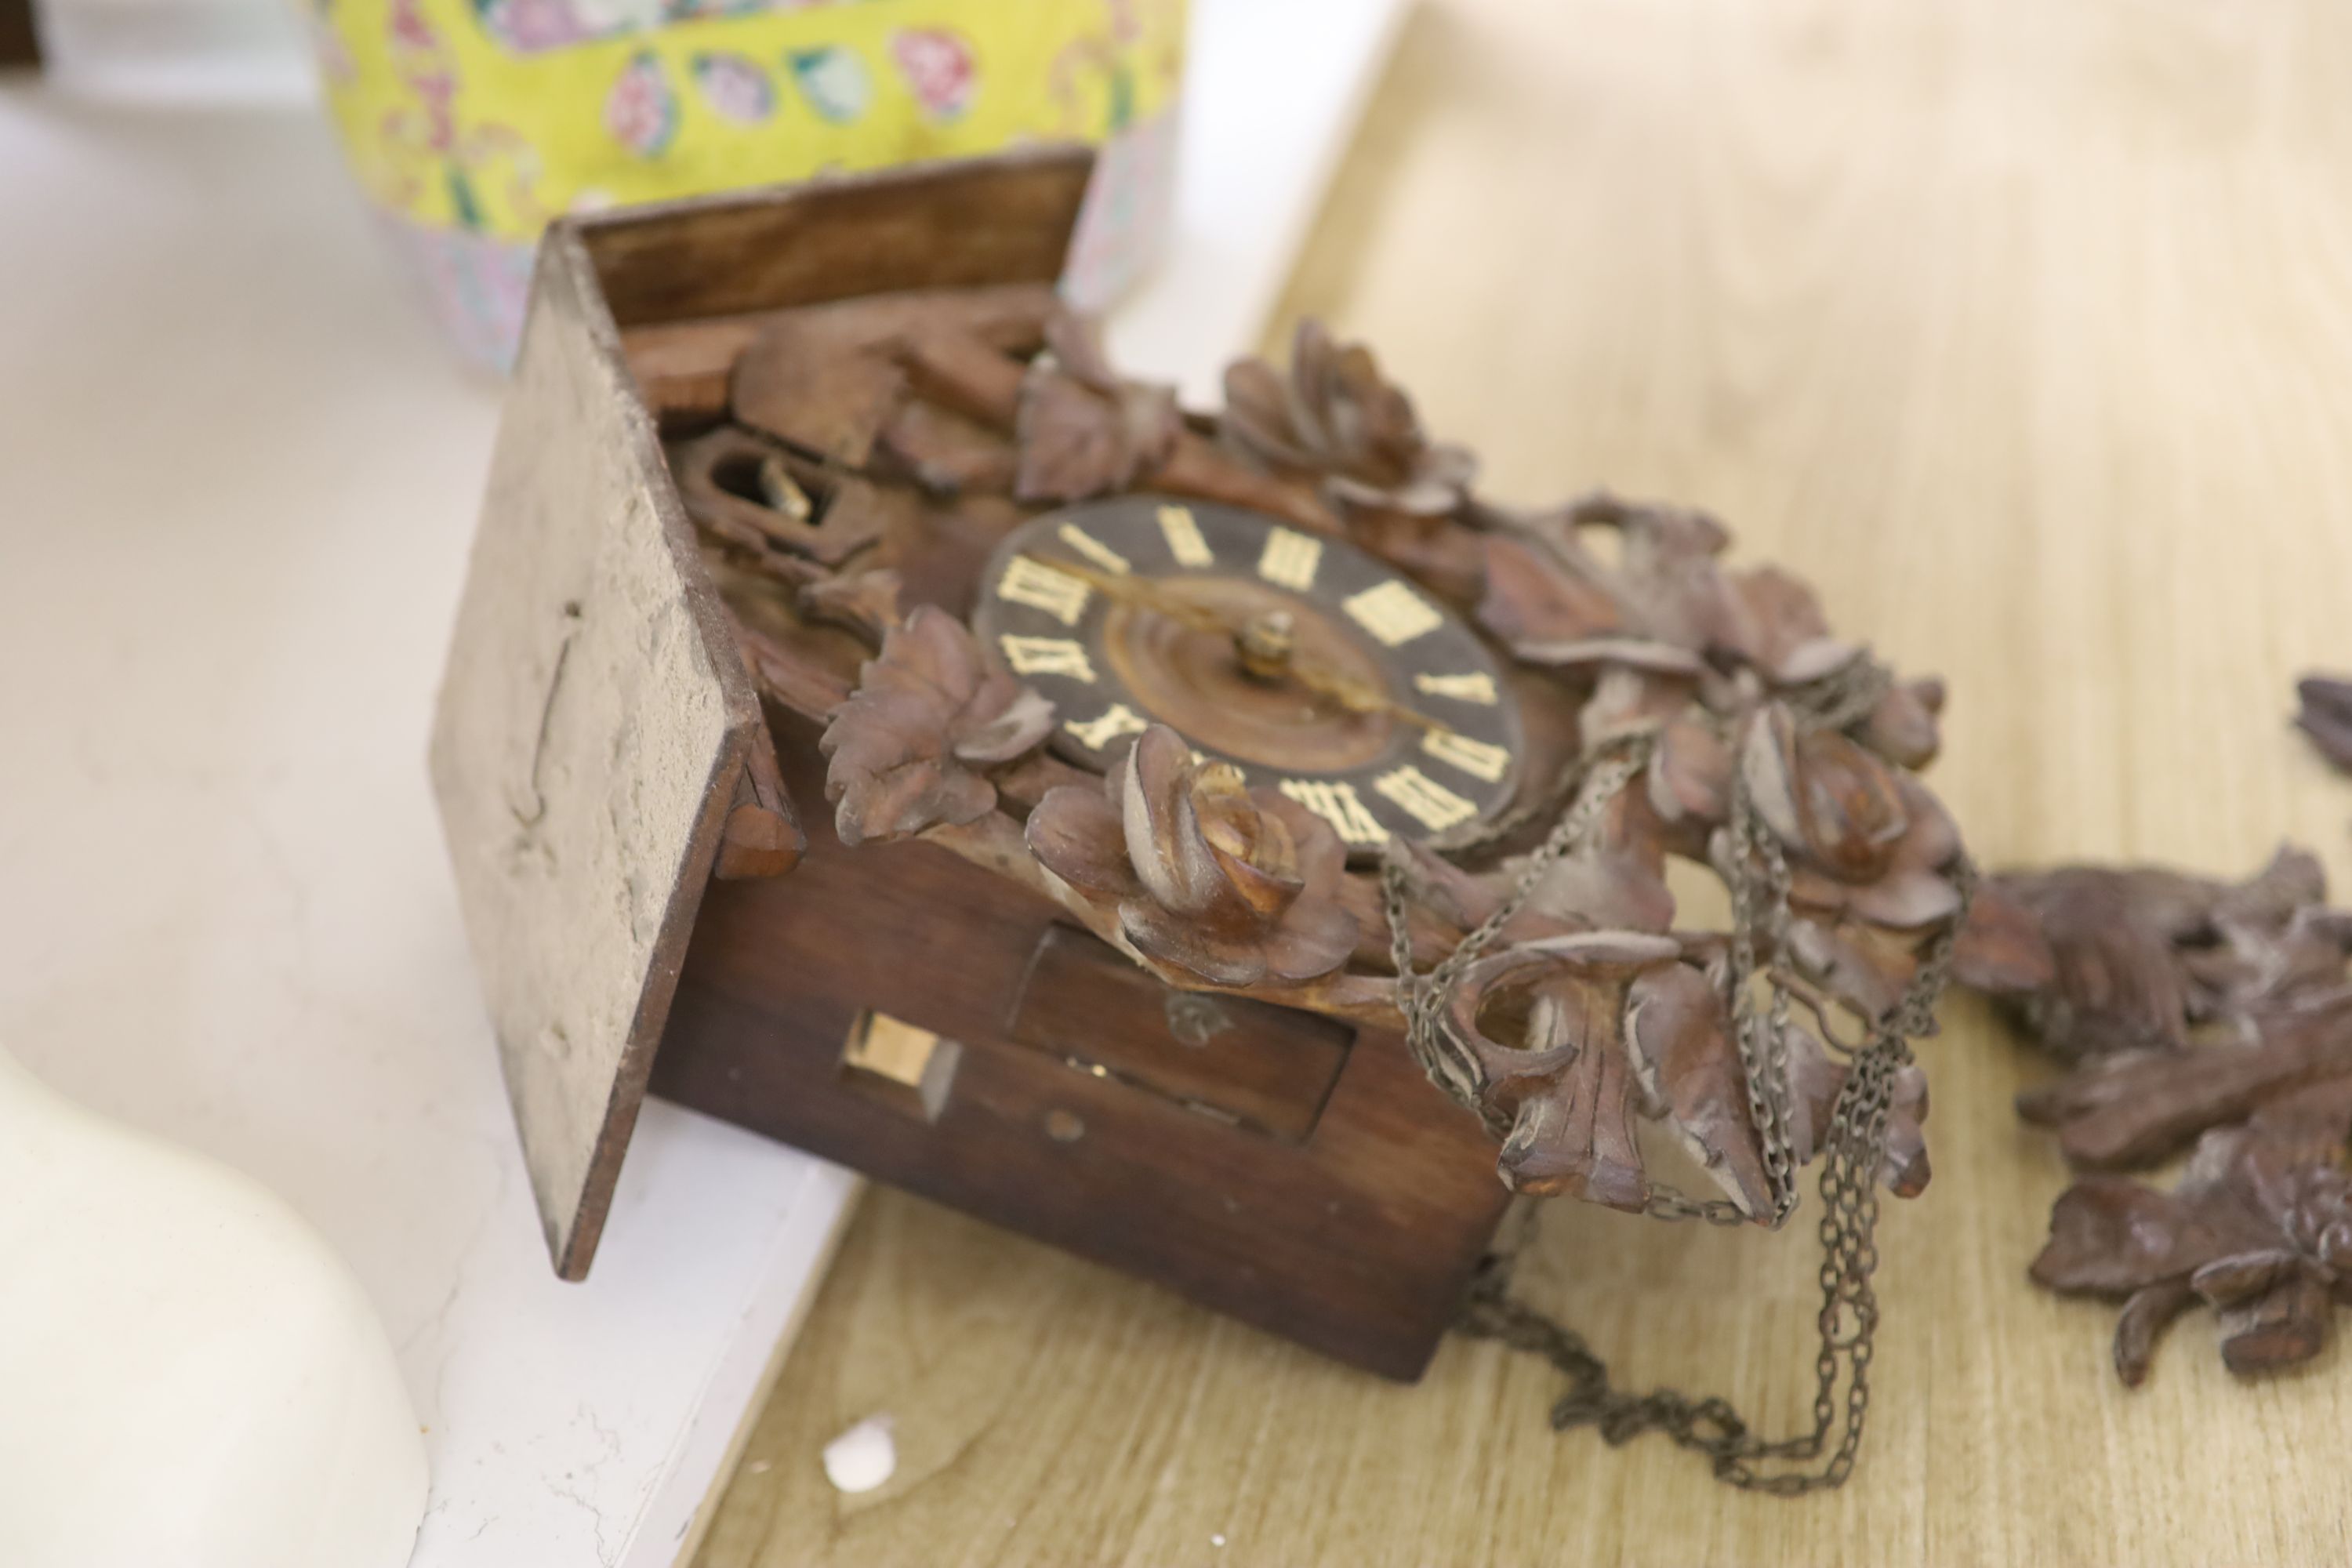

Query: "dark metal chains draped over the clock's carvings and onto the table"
(1383, 656), (1976, 1497)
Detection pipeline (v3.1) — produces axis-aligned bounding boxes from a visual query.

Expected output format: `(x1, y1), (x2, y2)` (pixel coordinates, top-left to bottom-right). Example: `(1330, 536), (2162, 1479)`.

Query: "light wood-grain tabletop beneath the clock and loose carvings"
(701, 0), (2352, 1568)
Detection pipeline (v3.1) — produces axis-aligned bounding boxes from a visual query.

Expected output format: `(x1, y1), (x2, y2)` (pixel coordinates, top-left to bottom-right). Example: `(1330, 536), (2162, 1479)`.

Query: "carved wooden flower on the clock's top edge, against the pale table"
(1221, 320), (1477, 517)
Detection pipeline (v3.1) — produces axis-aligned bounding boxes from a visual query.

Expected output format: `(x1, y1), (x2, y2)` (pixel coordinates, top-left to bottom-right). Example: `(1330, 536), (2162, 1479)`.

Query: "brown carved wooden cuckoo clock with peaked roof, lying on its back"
(435, 153), (1969, 1420)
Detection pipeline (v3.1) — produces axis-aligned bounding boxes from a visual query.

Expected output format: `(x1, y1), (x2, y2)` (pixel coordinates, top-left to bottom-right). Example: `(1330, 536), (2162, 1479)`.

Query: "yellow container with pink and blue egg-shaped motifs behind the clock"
(315, 0), (1185, 365)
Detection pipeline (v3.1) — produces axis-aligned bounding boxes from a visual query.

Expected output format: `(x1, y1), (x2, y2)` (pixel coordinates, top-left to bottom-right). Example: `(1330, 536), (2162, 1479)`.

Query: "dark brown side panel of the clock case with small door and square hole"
(654, 731), (1508, 1377)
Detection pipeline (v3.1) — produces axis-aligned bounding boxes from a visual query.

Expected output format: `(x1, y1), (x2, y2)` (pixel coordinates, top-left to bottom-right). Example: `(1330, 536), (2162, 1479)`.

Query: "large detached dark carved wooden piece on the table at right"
(1955, 846), (2352, 1385)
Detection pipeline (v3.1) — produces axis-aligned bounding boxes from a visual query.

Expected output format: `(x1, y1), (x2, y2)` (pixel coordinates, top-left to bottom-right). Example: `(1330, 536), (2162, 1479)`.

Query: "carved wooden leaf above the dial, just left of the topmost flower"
(1014, 310), (1183, 501)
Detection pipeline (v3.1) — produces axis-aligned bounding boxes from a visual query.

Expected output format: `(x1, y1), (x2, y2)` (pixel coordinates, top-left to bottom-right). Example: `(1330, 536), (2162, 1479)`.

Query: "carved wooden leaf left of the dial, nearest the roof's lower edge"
(818, 604), (1054, 848)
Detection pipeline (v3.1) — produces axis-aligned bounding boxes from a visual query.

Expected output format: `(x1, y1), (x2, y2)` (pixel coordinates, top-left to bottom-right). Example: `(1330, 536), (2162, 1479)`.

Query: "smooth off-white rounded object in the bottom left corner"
(0, 1051), (426, 1568)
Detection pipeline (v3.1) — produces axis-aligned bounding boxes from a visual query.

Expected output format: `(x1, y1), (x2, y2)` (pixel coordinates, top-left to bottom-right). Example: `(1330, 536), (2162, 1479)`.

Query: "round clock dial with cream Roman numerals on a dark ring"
(971, 496), (1522, 855)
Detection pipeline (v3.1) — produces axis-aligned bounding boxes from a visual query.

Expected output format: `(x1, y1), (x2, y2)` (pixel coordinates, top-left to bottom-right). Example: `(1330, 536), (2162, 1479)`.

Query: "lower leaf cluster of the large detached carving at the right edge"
(2032, 1079), (2352, 1385)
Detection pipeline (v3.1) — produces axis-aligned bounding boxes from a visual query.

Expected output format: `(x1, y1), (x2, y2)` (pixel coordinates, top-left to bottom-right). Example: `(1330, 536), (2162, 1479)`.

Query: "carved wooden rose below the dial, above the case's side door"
(1028, 724), (1357, 985)
